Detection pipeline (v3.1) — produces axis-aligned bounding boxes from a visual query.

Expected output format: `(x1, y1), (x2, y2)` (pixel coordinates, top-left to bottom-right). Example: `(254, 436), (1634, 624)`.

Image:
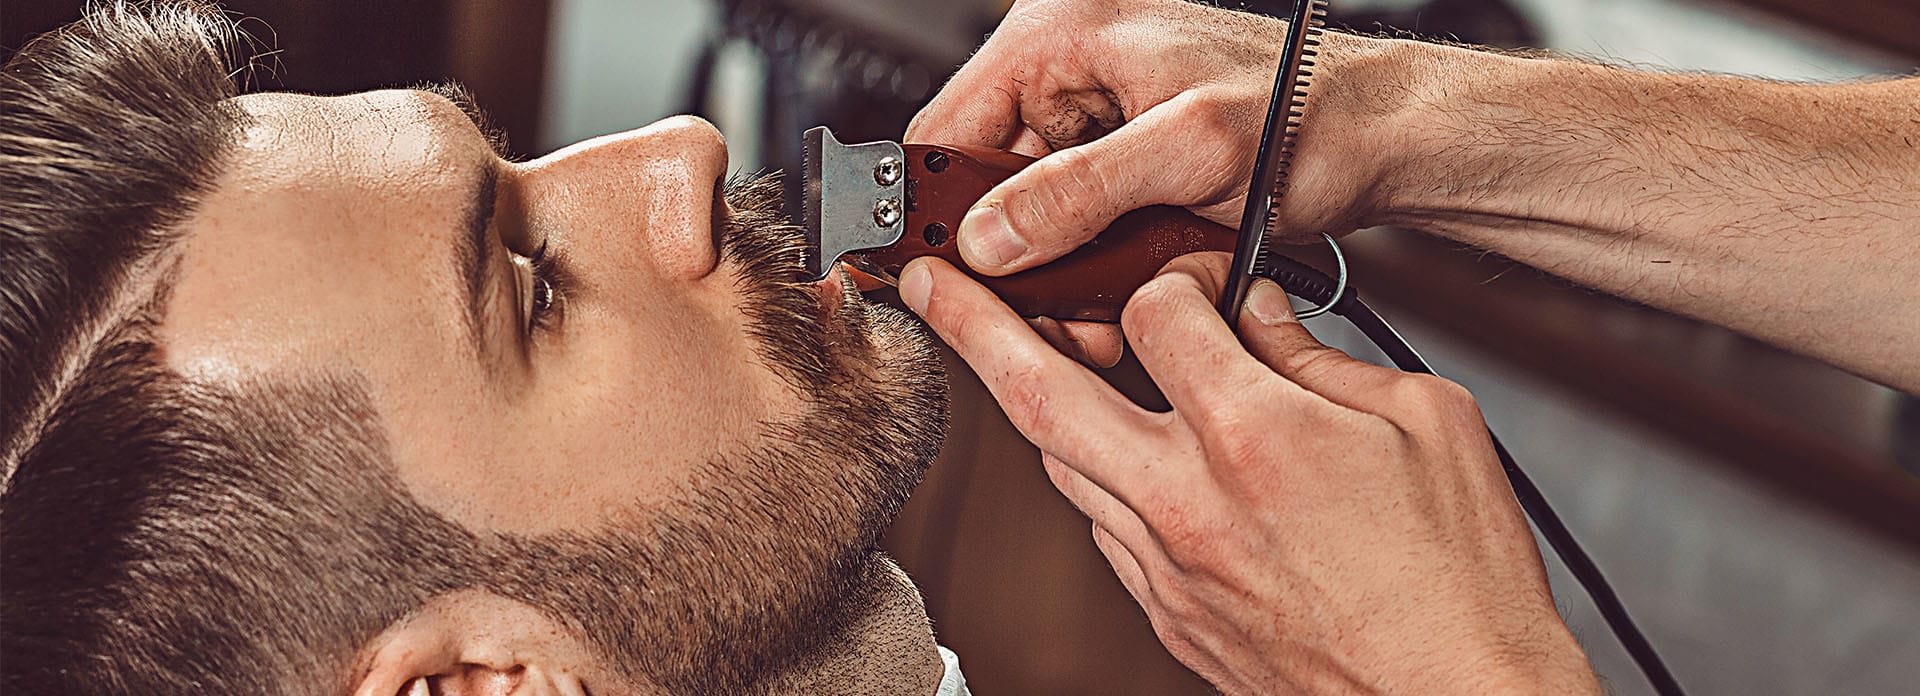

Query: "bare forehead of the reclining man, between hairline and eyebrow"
(163, 90), (488, 377)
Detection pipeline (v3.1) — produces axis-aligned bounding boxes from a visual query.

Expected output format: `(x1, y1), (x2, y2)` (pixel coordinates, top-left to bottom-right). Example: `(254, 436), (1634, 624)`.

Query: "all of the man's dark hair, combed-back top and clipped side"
(0, 2), (476, 694)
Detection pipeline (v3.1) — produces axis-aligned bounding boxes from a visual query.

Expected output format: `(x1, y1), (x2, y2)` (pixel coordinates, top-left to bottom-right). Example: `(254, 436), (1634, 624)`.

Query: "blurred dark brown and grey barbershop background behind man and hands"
(0, 0), (1920, 694)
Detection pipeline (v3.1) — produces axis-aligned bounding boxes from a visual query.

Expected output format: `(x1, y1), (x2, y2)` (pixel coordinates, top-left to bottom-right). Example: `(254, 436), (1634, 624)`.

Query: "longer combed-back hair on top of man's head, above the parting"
(0, 2), (242, 451)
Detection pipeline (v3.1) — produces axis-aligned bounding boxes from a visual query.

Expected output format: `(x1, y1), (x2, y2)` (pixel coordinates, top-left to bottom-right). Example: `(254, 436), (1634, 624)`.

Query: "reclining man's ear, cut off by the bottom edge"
(353, 596), (584, 696)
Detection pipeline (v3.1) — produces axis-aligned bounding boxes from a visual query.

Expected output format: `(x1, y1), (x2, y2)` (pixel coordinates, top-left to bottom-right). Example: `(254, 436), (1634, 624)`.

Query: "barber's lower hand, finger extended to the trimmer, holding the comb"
(900, 254), (1597, 694)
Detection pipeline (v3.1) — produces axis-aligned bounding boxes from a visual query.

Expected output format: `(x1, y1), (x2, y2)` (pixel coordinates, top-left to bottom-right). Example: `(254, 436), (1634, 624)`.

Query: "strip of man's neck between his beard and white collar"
(766, 552), (945, 696)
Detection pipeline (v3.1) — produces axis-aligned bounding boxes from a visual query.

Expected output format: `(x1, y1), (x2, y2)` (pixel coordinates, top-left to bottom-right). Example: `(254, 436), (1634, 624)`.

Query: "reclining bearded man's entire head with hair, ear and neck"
(0, 4), (956, 694)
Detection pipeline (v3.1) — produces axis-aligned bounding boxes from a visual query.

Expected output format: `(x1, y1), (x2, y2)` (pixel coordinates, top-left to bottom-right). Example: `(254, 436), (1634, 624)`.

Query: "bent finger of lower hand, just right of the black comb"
(1240, 279), (1405, 413)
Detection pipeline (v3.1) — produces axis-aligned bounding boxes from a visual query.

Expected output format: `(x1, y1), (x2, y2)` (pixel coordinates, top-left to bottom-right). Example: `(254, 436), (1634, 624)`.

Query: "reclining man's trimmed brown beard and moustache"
(490, 177), (947, 694)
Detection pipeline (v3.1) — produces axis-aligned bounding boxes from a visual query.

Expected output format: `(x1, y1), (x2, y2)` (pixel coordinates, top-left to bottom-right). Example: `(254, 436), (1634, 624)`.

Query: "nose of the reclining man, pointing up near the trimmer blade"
(520, 115), (726, 281)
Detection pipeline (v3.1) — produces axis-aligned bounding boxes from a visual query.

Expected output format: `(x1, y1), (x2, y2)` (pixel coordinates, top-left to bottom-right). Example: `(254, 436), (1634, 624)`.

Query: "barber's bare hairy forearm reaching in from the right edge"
(1359, 44), (1920, 390)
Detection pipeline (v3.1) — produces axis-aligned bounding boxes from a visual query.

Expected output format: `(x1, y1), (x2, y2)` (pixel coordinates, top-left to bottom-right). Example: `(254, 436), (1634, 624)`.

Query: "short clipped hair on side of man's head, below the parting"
(0, 328), (480, 694)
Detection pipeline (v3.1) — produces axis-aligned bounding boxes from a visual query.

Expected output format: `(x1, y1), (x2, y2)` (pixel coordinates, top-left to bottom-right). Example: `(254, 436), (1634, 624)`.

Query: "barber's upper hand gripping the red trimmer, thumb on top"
(906, 0), (1392, 275)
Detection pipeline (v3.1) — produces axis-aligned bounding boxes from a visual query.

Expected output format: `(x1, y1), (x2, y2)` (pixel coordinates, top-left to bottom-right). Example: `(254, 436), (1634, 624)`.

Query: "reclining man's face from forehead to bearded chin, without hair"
(161, 90), (945, 692)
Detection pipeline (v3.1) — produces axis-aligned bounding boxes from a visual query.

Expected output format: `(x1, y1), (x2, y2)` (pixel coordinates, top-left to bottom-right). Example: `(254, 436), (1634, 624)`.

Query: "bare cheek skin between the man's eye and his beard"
(439, 284), (799, 533)
